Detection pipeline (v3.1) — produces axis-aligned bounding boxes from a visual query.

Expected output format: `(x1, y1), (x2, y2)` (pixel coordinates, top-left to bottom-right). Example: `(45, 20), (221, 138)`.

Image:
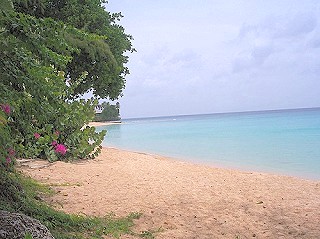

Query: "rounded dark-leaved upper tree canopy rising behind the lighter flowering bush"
(13, 0), (135, 99)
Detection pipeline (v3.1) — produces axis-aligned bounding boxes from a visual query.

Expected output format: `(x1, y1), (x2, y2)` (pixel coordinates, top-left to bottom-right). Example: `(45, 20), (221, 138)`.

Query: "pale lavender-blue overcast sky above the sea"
(106, 0), (320, 118)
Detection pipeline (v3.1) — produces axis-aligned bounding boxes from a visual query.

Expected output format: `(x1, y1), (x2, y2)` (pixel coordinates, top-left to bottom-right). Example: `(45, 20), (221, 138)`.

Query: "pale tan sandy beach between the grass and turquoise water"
(22, 148), (320, 239)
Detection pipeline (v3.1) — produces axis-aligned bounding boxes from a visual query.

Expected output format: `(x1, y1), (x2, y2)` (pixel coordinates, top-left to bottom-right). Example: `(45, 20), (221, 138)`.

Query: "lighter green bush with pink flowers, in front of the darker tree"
(0, 2), (115, 161)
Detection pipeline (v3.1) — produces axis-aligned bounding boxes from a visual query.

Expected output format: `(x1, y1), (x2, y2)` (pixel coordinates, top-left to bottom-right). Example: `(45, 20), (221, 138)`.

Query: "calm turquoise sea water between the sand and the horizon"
(97, 108), (320, 180)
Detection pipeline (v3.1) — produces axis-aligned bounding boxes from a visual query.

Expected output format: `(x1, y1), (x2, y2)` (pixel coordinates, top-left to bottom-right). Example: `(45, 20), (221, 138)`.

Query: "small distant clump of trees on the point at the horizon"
(94, 102), (121, 121)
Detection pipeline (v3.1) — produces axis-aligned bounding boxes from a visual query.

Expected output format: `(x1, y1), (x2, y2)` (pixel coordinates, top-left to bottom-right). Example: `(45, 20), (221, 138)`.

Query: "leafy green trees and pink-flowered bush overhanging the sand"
(0, 0), (131, 160)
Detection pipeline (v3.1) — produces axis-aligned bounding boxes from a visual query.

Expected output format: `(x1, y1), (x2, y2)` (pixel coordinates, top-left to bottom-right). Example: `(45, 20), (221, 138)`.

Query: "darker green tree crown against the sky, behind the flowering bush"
(46, 0), (134, 99)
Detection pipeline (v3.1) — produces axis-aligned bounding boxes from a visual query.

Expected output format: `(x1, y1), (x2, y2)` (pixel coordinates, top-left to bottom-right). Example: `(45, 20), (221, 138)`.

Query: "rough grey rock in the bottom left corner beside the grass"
(0, 210), (54, 239)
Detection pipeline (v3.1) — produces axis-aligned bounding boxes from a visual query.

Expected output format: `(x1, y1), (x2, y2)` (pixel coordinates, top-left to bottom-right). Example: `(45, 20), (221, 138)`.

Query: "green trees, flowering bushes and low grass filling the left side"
(0, 0), (152, 238)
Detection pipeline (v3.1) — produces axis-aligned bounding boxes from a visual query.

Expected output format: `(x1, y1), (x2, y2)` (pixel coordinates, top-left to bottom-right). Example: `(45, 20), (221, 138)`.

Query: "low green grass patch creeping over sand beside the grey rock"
(0, 172), (154, 239)
